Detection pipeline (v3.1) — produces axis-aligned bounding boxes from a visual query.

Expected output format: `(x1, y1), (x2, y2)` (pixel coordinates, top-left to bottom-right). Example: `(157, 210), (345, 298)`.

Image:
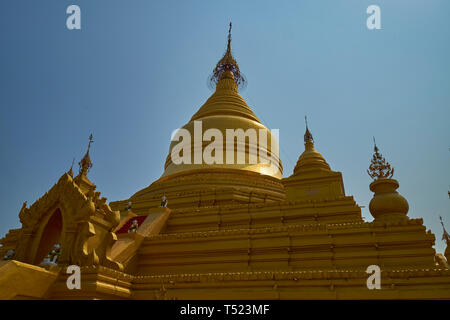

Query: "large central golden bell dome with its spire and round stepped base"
(129, 25), (285, 206)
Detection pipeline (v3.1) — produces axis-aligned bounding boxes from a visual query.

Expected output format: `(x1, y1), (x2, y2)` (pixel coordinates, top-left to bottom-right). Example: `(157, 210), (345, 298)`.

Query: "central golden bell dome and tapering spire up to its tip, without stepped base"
(162, 24), (283, 179)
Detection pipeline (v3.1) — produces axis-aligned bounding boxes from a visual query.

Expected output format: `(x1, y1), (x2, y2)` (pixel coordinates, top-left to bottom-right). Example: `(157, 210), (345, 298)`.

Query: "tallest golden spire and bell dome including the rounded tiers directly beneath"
(120, 24), (285, 210)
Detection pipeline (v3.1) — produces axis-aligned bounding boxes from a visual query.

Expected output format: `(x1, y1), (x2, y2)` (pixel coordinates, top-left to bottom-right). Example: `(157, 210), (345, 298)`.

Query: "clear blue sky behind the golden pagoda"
(0, 0), (450, 252)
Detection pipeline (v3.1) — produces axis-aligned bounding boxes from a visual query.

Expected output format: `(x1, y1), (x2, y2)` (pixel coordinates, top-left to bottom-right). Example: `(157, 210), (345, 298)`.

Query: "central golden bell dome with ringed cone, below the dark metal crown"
(162, 71), (283, 179)
